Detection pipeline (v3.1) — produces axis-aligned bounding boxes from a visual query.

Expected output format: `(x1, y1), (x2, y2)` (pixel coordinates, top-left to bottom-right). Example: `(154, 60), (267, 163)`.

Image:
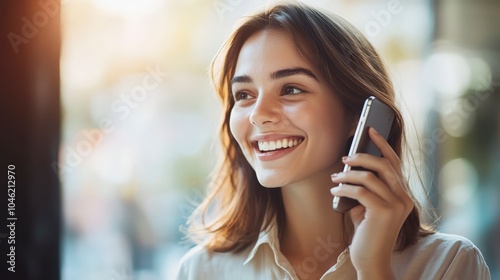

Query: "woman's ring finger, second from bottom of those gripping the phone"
(332, 170), (395, 201)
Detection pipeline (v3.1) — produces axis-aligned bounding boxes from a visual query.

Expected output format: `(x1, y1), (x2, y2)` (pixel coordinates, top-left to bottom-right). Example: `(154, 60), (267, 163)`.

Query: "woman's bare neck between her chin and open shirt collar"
(280, 168), (344, 263)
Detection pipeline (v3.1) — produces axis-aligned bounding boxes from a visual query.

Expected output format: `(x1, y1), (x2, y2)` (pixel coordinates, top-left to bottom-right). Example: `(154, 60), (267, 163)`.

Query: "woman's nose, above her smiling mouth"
(250, 94), (282, 126)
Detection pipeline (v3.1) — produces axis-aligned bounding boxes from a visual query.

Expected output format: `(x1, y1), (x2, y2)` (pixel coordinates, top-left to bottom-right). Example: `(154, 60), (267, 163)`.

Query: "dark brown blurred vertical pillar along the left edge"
(0, 0), (61, 280)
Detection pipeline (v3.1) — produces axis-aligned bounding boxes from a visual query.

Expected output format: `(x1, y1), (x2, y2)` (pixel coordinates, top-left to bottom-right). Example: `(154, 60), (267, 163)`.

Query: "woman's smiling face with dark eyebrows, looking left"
(230, 30), (355, 187)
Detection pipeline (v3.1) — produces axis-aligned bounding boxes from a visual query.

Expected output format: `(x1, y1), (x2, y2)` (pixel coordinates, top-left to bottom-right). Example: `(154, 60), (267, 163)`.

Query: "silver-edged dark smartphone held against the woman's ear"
(333, 96), (394, 213)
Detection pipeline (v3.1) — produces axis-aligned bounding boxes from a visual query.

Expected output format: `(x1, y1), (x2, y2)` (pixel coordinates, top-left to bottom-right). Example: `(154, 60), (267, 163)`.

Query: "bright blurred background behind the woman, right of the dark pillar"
(0, 0), (500, 280)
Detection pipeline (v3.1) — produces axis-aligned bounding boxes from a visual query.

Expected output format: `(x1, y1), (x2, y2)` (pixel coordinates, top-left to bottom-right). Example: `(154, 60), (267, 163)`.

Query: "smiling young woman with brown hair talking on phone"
(178, 4), (489, 279)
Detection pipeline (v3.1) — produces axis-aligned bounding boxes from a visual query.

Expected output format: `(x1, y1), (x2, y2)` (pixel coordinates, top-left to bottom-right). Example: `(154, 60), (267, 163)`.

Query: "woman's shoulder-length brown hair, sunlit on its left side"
(188, 3), (431, 252)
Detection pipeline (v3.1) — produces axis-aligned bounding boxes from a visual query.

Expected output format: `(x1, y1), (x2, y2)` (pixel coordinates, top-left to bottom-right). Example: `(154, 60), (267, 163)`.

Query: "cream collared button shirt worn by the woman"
(176, 226), (490, 280)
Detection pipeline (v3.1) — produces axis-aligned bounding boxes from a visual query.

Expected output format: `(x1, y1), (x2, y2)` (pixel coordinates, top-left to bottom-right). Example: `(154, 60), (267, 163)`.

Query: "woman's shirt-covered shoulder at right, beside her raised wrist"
(393, 233), (490, 279)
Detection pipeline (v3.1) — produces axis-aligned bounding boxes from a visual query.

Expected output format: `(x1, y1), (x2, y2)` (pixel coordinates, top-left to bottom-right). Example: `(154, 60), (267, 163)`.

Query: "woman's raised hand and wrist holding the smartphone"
(331, 128), (414, 279)
